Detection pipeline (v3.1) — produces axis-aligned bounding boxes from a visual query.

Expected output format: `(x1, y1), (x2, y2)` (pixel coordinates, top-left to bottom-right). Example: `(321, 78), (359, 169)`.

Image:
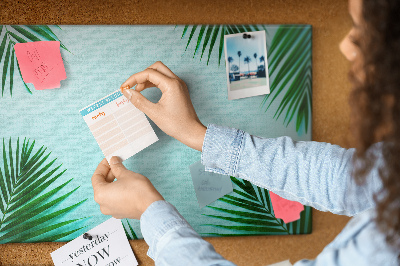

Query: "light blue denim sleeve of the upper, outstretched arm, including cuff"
(201, 124), (382, 216)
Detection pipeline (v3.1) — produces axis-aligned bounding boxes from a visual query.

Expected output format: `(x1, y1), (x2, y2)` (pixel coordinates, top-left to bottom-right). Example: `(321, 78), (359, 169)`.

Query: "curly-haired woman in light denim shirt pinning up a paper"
(92, 0), (400, 266)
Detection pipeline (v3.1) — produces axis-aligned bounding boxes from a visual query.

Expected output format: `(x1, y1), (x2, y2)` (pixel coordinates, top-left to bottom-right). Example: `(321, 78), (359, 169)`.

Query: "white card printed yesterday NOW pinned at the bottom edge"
(51, 218), (138, 266)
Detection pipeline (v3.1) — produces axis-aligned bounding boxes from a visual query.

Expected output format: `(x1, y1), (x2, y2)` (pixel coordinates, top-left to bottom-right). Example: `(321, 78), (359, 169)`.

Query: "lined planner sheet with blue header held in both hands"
(80, 90), (158, 161)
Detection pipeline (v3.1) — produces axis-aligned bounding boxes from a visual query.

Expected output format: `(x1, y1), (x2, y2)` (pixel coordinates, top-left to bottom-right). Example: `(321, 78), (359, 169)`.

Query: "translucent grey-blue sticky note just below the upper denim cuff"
(190, 161), (233, 208)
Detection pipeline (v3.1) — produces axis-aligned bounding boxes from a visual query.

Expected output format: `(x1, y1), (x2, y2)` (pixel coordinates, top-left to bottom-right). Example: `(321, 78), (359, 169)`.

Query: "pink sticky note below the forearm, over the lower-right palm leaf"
(269, 191), (304, 223)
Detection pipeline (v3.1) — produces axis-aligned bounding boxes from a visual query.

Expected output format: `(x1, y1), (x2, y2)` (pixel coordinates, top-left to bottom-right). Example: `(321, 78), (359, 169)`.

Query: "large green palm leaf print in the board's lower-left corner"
(0, 138), (86, 243)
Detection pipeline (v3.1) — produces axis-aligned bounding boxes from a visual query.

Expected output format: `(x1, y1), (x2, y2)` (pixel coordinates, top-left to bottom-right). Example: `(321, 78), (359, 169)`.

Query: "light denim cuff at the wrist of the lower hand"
(140, 200), (192, 260)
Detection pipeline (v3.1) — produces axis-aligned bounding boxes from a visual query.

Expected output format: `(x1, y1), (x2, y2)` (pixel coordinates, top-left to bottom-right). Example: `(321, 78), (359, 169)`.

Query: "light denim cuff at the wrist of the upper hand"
(201, 124), (244, 176)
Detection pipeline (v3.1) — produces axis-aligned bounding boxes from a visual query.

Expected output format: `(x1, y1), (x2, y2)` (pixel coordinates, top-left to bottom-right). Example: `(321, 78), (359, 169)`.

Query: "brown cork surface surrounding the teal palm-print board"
(0, 1), (351, 265)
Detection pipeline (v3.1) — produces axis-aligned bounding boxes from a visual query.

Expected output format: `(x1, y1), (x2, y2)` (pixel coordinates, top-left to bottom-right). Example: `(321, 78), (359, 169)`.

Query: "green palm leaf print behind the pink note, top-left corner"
(0, 25), (69, 97)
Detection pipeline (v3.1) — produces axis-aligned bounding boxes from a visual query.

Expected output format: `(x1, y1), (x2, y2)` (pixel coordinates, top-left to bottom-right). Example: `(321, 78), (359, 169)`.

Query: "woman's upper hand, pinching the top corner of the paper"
(121, 61), (207, 151)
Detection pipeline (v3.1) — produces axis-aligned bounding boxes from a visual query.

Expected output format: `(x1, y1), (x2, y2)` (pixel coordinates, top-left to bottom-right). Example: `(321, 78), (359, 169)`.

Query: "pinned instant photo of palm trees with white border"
(224, 31), (270, 100)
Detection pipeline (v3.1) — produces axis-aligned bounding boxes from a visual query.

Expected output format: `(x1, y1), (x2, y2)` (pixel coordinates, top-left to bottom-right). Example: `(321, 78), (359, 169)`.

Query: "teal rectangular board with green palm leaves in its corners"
(0, 24), (312, 244)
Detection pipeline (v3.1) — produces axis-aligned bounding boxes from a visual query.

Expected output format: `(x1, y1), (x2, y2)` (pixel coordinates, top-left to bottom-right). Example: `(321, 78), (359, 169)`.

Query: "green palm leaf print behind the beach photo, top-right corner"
(177, 25), (312, 133)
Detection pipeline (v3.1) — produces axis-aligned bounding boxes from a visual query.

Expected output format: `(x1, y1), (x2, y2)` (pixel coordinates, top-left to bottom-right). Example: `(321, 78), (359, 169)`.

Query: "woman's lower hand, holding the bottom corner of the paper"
(92, 157), (164, 219)
